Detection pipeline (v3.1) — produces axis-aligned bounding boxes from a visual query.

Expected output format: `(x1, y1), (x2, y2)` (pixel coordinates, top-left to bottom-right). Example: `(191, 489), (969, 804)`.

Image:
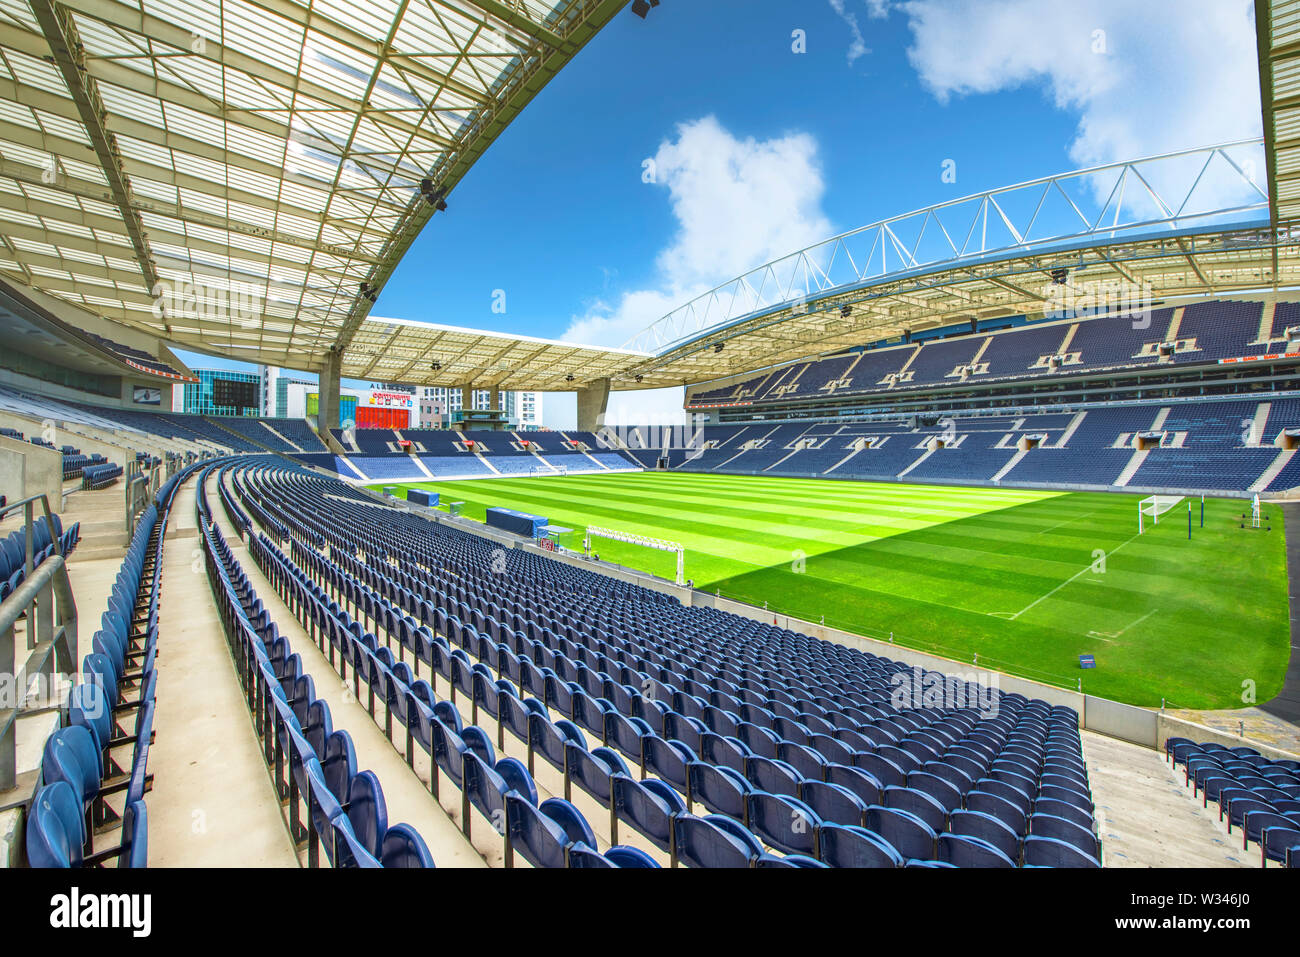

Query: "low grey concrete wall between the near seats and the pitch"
(365, 478), (1300, 761)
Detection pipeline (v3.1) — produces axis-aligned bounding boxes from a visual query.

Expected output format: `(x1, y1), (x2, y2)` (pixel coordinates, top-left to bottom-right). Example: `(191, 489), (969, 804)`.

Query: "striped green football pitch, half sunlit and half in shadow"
(374, 472), (1290, 709)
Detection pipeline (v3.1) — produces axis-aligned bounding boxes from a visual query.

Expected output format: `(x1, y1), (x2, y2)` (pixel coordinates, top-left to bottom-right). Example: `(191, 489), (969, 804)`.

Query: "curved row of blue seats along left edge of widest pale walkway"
(26, 469), (189, 867)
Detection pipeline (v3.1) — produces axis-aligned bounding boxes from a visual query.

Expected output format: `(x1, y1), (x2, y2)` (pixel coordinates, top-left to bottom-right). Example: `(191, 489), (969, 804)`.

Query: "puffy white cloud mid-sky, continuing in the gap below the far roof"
(563, 117), (833, 423)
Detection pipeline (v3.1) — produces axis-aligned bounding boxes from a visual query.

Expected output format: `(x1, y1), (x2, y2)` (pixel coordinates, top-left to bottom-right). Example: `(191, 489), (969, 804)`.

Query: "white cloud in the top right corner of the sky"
(896, 0), (1262, 208)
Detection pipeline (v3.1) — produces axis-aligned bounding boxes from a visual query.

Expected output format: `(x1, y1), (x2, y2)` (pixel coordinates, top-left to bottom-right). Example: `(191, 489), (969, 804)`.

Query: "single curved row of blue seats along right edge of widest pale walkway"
(196, 468), (434, 867)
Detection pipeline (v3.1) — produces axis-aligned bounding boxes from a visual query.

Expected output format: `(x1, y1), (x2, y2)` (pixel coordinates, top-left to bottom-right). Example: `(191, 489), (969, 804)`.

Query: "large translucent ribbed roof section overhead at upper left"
(0, 0), (627, 368)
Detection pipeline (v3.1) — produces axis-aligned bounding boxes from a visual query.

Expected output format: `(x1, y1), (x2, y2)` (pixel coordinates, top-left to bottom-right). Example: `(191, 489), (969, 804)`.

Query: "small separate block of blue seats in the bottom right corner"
(1165, 737), (1300, 867)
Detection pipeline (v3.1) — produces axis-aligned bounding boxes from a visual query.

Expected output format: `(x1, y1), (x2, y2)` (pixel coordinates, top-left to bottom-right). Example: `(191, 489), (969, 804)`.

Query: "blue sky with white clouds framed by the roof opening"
(178, 0), (1260, 426)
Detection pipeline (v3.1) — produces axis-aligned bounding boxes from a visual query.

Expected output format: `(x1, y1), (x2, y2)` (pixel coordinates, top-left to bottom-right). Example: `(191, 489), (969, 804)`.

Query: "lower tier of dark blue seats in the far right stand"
(670, 398), (1300, 493)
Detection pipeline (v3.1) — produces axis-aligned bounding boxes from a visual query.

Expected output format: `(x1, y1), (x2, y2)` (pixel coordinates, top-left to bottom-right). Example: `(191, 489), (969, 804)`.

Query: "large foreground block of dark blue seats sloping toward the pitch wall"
(218, 465), (1101, 867)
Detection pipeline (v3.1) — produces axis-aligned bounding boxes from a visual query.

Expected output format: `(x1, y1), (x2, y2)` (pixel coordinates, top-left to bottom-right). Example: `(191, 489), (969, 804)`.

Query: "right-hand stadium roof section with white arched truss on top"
(614, 140), (1300, 389)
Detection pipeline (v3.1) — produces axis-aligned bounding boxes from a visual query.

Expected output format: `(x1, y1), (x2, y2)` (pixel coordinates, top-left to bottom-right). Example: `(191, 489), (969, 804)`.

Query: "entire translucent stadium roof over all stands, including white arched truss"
(10, 0), (1300, 389)
